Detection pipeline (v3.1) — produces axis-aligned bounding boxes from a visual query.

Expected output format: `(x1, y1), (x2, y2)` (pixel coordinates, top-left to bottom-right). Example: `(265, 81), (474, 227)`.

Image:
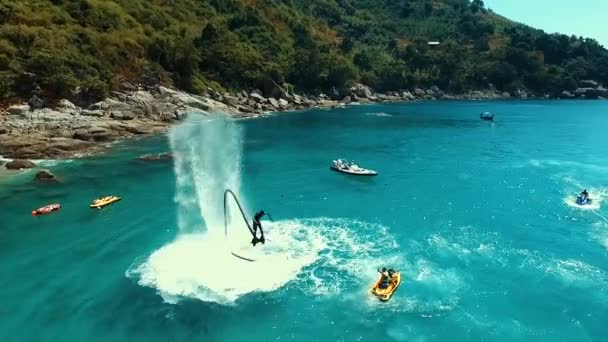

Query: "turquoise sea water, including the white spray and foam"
(0, 101), (608, 342)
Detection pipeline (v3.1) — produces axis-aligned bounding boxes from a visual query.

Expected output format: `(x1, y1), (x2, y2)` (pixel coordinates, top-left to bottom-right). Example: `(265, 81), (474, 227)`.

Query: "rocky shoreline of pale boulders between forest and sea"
(0, 82), (604, 169)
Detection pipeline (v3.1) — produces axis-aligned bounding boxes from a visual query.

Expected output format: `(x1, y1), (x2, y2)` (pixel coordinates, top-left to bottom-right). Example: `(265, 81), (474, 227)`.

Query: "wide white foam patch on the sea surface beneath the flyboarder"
(127, 218), (394, 304)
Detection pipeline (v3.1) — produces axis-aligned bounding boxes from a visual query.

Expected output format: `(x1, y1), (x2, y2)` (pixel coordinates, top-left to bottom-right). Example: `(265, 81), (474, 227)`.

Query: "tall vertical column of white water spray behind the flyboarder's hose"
(169, 115), (241, 234)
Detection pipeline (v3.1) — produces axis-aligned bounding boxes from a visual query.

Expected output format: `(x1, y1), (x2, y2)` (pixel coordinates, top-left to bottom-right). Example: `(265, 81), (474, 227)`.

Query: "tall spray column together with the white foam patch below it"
(126, 115), (396, 304)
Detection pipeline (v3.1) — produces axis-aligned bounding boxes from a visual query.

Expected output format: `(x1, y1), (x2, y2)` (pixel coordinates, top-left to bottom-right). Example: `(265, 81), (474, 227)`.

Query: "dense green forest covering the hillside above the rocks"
(0, 0), (608, 98)
